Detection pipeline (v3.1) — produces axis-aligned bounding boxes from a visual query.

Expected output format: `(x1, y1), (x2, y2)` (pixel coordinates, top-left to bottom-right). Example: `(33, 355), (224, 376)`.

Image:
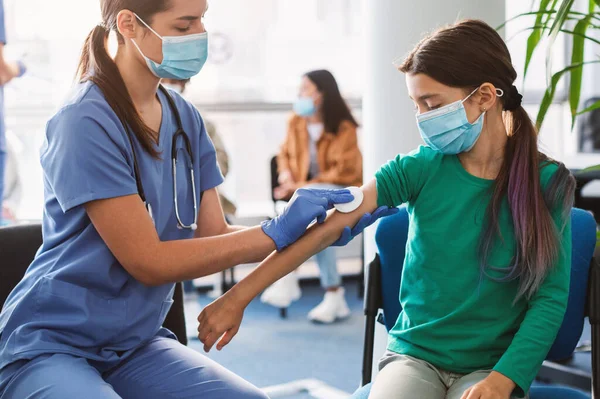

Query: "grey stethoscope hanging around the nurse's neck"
(123, 85), (198, 231)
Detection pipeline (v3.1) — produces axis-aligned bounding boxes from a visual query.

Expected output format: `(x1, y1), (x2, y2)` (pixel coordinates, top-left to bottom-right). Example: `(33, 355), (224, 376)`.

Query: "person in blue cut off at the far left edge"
(0, 0), (25, 226)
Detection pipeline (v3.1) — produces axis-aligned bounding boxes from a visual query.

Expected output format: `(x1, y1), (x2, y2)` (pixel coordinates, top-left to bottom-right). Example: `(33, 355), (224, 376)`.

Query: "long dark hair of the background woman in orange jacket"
(305, 69), (358, 134)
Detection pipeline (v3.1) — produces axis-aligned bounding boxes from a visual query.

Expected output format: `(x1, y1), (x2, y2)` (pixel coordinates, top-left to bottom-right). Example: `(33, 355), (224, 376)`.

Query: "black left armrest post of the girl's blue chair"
(361, 255), (382, 386)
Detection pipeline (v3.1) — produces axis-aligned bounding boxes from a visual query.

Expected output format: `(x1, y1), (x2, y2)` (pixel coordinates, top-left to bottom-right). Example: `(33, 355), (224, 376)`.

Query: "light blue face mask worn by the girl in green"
(417, 88), (485, 155)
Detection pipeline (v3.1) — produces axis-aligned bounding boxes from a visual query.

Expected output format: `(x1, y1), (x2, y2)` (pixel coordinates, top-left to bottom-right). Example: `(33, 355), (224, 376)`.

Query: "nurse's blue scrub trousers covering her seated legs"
(0, 337), (268, 399)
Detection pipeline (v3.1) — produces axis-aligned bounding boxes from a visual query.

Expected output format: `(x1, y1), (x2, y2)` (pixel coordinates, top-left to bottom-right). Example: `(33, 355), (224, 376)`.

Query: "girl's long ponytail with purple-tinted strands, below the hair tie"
(480, 101), (575, 301)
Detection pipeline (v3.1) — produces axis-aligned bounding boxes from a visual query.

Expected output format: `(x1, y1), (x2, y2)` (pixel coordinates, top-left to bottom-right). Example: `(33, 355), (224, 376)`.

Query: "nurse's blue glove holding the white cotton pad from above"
(262, 188), (354, 251)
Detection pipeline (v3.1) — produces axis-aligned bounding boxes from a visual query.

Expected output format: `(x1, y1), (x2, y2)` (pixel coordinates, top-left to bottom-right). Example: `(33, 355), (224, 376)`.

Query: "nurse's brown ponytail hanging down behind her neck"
(77, 25), (160, 158)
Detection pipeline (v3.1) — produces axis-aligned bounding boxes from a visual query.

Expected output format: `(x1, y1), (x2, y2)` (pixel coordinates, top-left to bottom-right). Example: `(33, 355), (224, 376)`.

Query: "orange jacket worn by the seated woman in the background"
(277, 115), (362, 187)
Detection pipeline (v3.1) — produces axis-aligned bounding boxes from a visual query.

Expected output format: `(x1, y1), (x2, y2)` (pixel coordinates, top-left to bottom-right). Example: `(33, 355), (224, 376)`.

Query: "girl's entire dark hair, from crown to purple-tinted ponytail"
(399, 20), (575, 301)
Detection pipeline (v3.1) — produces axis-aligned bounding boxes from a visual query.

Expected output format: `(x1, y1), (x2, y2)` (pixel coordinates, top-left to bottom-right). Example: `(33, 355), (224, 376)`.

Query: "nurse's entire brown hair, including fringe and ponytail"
(77, 0), (170, 158)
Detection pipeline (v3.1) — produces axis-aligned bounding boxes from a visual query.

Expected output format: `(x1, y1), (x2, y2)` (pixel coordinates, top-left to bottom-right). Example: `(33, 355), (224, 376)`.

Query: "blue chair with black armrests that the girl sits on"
(352, 208), (600, 399)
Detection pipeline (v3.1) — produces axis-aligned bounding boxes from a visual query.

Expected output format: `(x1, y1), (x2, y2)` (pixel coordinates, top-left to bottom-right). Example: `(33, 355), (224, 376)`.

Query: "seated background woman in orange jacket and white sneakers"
(262, 70), (362, 323)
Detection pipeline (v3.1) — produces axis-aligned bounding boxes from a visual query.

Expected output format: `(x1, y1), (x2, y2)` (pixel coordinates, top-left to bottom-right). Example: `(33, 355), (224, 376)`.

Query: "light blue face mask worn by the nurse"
(131, 14), (208, 80)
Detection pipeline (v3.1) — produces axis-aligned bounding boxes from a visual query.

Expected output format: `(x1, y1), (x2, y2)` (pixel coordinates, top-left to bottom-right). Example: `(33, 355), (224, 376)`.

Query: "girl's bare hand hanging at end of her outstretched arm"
(198, 289), (248, 352)
